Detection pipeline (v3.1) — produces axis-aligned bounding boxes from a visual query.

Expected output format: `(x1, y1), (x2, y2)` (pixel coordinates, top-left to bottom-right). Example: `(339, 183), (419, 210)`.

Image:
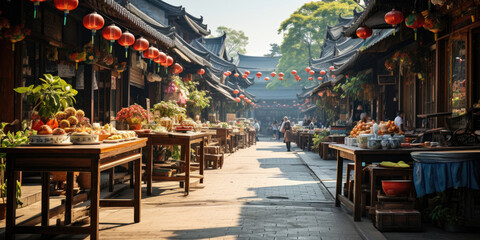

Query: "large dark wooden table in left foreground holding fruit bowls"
(0, 139), (147, 239)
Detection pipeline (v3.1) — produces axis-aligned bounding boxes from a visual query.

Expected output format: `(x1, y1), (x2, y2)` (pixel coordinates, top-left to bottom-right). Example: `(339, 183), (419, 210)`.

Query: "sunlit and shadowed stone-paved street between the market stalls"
(81, 141), (361, 239)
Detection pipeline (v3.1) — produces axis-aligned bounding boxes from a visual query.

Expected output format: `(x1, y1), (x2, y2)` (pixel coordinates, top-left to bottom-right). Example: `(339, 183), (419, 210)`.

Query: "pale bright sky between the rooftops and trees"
(172, 0), (312, 56)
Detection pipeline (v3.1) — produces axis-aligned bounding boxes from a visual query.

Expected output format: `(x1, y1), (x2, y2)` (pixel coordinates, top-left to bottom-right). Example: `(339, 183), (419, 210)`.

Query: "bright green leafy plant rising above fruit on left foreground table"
(13, 74), (78, 118)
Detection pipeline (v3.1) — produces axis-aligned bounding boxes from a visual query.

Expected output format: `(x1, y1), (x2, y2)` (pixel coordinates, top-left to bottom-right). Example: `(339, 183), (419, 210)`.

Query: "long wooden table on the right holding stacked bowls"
(329, 144), (480, 221)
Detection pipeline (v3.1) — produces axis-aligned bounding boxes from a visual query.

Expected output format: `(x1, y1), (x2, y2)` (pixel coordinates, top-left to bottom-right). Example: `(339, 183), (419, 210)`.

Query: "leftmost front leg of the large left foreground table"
(5, 157), (17, 239)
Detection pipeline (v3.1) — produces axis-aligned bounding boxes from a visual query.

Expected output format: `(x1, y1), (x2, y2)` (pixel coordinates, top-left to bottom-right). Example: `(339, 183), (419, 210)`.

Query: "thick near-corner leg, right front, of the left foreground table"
(90, 163), (100, 240)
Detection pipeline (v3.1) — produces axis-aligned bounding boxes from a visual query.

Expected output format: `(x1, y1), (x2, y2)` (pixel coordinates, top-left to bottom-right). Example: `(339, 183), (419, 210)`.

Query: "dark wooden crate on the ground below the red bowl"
(375, 209), (422, 231)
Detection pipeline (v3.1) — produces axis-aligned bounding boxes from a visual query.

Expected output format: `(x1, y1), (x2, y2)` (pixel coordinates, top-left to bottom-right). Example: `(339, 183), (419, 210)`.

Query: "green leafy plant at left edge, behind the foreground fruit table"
(0, 121), (30, 219)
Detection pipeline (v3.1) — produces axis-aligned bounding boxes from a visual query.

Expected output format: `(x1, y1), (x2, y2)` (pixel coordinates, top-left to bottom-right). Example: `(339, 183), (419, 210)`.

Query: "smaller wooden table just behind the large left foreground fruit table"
(144, 132), (208, 196)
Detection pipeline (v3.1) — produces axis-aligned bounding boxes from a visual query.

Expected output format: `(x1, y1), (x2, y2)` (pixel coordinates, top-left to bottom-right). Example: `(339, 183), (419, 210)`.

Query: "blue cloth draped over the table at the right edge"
(412, 152), (480, 197)
